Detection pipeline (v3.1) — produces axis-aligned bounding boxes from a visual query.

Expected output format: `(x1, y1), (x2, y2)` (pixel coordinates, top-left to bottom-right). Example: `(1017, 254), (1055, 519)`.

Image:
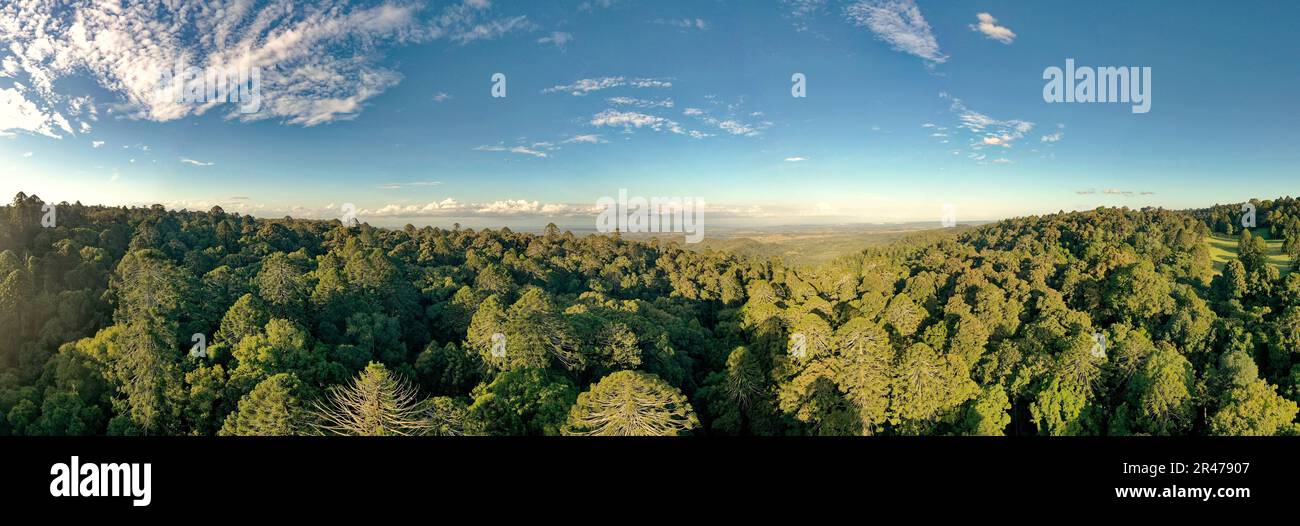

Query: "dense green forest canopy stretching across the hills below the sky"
(0, 194), (1300, 435)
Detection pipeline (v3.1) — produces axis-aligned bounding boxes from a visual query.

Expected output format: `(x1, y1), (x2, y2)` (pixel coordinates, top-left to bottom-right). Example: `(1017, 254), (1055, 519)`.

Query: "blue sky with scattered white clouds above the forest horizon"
(0, 0), (1300, 227)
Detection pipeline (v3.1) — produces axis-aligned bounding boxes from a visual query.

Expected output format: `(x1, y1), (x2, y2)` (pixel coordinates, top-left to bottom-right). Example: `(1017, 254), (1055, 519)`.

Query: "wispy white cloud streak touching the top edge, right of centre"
(845, 0), (948, 64)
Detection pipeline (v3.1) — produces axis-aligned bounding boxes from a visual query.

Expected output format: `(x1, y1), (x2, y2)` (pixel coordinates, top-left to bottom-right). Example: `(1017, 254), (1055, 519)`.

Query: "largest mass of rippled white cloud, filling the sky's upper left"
(0, 0), (530, 129)
